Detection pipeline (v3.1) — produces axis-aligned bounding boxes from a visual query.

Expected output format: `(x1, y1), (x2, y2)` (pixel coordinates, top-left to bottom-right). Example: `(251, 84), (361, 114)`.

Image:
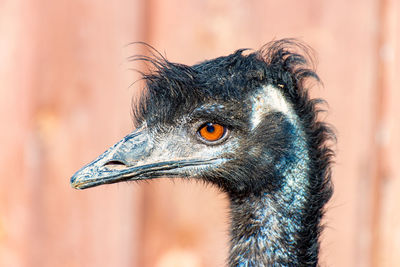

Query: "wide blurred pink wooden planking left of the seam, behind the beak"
(0, 0), (141, 266)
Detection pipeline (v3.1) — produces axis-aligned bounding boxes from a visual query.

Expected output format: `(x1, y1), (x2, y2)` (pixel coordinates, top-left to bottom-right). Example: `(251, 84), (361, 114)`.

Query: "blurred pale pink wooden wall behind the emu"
(0, 0), (400, 267)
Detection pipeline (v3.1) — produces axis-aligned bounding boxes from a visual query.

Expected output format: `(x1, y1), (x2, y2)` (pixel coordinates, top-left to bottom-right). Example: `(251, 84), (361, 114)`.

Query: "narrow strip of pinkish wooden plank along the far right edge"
(372, 1), (400, 266)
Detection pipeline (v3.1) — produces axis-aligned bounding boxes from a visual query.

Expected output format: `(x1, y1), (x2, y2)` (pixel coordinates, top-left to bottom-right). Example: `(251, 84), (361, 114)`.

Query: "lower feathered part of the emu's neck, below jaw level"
(229, 189), (312, 266)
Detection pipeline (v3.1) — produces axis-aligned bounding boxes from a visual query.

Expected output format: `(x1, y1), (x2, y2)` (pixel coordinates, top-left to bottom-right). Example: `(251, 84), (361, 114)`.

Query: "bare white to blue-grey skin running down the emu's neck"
(231, 86), (309, 266)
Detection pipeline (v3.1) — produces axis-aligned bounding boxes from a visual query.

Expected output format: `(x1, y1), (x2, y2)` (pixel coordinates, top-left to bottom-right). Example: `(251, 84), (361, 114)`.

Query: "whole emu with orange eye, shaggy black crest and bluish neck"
(71, 39), (334, 266)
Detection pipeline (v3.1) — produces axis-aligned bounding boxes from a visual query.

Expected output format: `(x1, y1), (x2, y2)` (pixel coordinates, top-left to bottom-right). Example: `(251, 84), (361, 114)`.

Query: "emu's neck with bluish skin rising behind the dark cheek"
(230, 127), (322, 266)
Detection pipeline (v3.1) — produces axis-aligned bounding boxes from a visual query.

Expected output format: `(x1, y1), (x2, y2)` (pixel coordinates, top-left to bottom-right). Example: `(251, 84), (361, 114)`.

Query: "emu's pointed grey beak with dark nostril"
(71, 127), (217, 189)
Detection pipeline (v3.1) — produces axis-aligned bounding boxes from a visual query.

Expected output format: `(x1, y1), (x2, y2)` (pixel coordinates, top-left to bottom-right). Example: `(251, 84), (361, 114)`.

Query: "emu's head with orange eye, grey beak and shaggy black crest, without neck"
(71, 40), (316, 198)
